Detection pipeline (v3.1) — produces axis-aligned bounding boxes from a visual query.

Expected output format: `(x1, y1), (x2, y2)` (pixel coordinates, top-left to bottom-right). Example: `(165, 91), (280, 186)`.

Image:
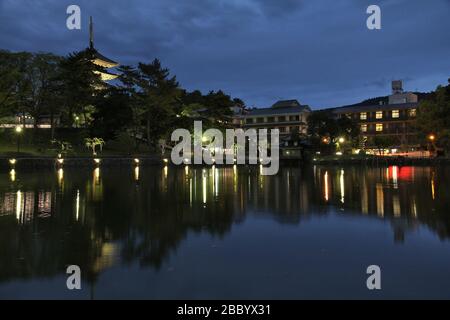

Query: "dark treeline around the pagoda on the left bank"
(0, 50), (244, 151)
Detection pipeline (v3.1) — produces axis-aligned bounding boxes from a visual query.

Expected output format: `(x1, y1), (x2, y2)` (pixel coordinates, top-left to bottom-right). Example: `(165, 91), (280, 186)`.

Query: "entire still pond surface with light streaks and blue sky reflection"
(0, 166), (450, 299)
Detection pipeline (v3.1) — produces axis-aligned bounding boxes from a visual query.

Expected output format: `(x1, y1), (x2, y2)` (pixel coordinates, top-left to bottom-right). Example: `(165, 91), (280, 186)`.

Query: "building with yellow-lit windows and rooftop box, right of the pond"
(329, 80), (420, 153)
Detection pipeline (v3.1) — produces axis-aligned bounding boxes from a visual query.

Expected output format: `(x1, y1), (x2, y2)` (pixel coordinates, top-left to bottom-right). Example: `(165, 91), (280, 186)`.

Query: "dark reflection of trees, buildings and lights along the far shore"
(0, 166), (450, 298)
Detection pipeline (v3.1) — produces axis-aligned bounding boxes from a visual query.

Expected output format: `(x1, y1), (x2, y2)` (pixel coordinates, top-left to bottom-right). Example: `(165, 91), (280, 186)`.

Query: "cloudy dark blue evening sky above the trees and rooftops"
(0, 0), (450, 109)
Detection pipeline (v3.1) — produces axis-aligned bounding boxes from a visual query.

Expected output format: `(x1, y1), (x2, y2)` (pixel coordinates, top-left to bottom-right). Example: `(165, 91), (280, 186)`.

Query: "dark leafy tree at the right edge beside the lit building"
(416, 85), (450, 153)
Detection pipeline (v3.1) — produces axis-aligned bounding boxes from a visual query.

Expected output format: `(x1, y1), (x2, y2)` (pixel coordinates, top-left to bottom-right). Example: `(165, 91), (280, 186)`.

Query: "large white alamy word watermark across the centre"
(171, 121), (280, 175)
